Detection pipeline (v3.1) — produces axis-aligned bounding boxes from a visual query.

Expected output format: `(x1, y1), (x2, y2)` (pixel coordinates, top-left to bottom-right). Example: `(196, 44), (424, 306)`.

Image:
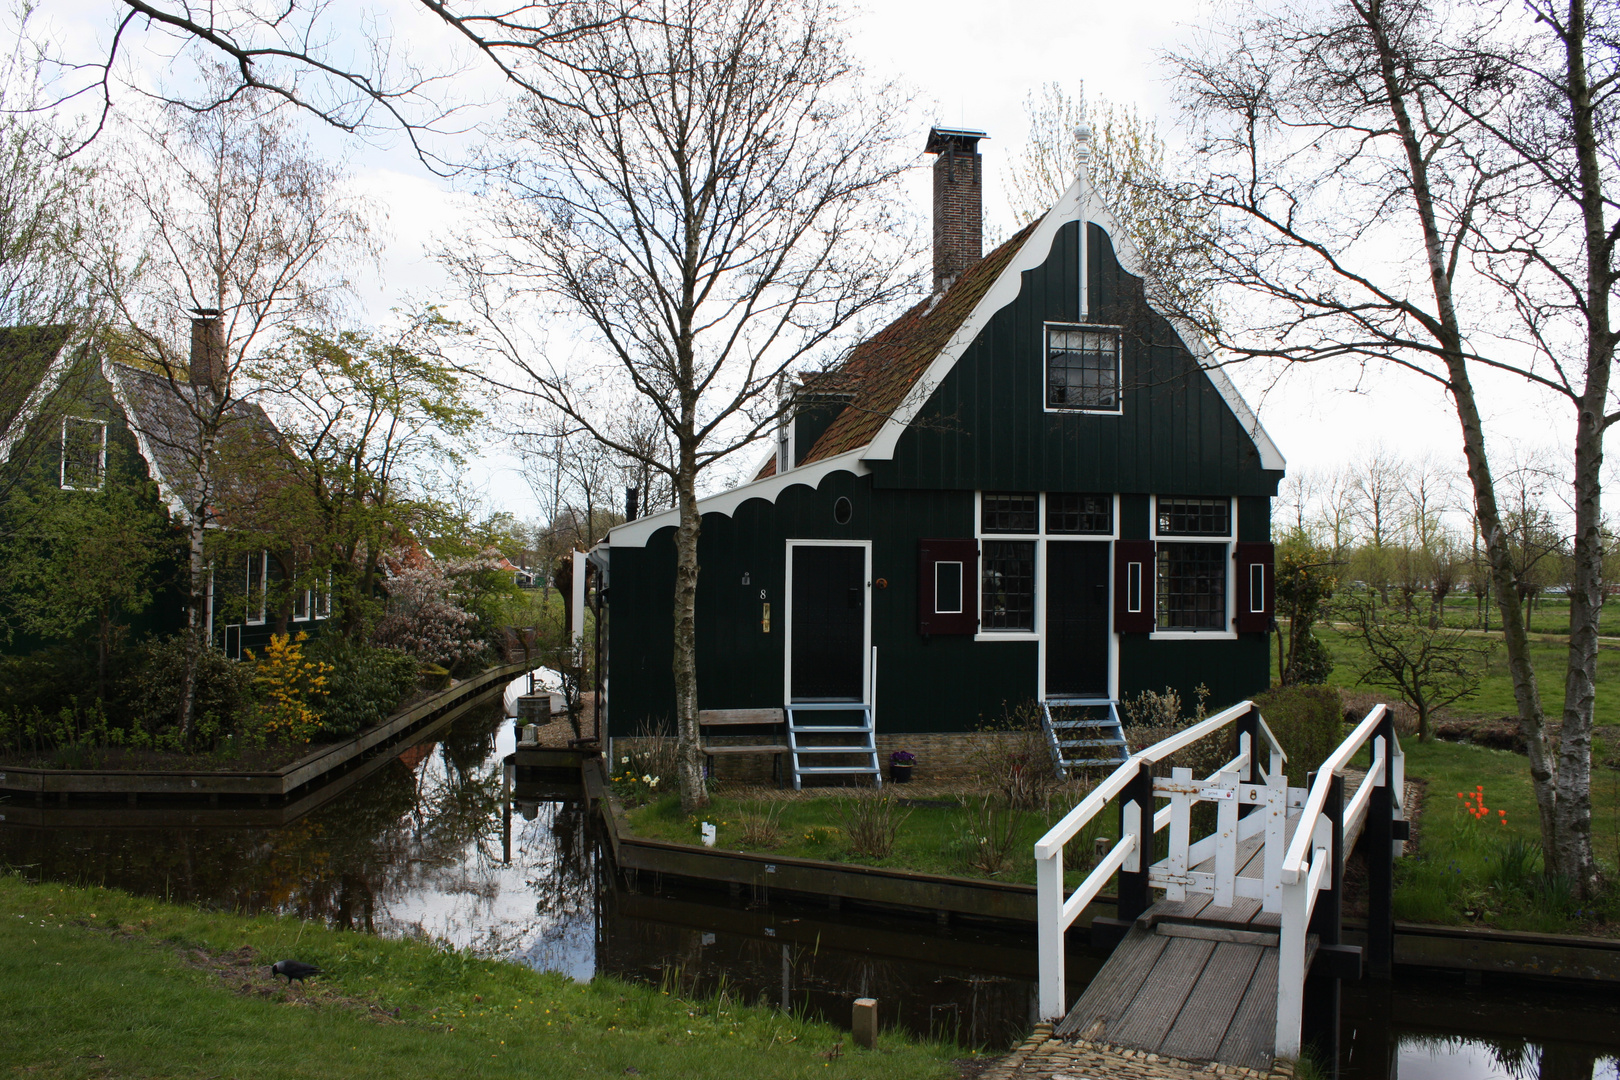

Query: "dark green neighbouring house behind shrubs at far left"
(0, 313), (330, 657)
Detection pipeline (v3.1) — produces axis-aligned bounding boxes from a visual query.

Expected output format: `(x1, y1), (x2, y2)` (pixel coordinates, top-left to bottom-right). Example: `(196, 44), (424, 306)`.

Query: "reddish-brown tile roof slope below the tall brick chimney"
(755, 222), (1038, 479)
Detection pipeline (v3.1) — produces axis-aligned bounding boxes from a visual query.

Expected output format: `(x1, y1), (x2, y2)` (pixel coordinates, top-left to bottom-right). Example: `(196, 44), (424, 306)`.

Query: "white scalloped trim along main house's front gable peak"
(862, 165), (1286, 471)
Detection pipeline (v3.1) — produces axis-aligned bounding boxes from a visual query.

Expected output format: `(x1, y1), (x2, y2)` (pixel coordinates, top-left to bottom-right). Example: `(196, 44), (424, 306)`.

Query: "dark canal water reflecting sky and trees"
(0, 709), (1620, 1080)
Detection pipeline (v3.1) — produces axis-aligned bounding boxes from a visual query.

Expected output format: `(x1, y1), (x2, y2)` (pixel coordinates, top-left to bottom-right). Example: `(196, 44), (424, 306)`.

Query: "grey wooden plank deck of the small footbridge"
(1053, 790), (1359, 1072)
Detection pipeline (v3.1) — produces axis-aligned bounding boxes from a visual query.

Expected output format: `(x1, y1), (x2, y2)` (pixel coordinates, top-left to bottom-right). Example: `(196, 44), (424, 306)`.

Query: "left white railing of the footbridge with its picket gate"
(1035, 701), (1288, 1020)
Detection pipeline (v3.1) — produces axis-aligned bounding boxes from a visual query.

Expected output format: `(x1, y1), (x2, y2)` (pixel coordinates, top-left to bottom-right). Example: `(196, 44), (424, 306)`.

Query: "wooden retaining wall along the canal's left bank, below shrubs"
(0, 664), (528, 809)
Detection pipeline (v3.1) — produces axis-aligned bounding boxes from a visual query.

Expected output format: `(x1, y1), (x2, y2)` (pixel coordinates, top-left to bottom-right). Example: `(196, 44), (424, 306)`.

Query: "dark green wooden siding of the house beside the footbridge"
(609, 216), (1281, 735)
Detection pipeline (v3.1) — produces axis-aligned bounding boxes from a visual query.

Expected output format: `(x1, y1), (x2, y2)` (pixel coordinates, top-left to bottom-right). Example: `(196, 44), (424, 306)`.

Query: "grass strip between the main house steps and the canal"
(625, 789), (1118, 884)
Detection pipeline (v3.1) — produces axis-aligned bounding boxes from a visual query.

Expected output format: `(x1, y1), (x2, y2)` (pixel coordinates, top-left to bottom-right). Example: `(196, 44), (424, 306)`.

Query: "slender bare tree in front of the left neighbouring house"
(94, 76), (369, 733)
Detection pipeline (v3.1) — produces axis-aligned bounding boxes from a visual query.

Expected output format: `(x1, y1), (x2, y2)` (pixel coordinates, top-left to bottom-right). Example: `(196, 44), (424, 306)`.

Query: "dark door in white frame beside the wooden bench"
(789, 547), (867, 701)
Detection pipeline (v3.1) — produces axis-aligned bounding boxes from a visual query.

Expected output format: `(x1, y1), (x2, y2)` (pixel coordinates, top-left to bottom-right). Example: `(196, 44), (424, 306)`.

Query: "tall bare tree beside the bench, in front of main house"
(452, 0), (910, 808)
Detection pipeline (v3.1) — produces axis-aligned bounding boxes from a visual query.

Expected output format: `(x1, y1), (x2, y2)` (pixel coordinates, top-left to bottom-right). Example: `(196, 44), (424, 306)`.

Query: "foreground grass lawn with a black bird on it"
(0, 876), (967, 1080)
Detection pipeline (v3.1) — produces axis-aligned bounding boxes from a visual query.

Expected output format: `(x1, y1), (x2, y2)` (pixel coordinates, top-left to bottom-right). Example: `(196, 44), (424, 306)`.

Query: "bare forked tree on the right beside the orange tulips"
(1173, 0), (1620, 891)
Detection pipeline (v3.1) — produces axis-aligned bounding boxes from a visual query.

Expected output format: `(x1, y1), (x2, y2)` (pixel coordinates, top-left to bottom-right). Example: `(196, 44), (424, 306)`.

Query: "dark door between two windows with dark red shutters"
(1047, 541), (1108, 698)
